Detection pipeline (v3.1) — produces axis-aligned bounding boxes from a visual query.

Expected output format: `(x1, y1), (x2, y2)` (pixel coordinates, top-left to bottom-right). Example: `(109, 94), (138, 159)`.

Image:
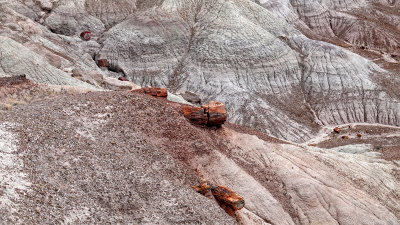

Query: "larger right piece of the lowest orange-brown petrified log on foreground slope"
(211, 185), (244, 211)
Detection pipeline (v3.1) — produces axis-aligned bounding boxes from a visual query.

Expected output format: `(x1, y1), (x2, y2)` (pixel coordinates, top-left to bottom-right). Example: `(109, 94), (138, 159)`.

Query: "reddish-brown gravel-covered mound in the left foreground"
(0, 92), (235, 224)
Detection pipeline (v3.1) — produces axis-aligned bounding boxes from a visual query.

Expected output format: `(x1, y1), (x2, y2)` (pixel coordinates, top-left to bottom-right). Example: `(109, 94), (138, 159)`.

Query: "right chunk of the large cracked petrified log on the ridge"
(202, 101), (228, 126)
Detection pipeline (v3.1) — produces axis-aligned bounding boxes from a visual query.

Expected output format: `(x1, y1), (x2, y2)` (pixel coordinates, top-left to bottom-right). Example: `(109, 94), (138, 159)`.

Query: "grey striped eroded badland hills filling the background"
(0, 0), (400, 142)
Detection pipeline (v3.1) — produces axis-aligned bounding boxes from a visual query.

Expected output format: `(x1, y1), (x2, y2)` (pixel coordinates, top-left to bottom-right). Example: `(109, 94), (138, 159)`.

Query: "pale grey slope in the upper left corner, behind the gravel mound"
(0, 2), (105, 90)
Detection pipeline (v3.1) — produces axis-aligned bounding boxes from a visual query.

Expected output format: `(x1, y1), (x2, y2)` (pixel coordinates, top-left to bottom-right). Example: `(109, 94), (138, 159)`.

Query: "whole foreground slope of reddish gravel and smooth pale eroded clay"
(0, 92), (400, 224)
